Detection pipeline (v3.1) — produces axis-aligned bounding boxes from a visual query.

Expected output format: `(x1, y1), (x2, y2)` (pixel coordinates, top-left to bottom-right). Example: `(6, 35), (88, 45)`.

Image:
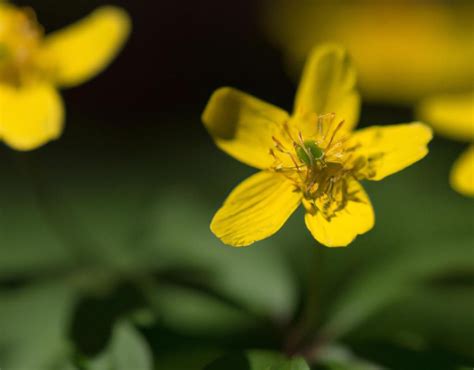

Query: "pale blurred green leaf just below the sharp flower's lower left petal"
(139, 189), (297, 321)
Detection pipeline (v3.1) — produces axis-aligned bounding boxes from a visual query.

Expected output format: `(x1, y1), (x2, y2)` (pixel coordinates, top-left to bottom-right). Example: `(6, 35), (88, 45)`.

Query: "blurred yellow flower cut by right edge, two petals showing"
(418, 92), (474, 197)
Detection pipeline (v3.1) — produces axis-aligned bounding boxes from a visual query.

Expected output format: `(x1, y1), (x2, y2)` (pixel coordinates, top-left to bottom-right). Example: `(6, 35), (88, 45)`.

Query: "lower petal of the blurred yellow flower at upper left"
(0, 84), (64, 150)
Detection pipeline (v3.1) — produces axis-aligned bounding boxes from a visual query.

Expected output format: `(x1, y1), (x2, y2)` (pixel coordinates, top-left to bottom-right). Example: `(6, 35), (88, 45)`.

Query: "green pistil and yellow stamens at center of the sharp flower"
(270, 114), (356, 219)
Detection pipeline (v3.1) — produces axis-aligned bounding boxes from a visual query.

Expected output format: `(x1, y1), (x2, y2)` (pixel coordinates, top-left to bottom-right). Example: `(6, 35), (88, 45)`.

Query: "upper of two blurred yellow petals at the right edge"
(417, 92), (474, 141)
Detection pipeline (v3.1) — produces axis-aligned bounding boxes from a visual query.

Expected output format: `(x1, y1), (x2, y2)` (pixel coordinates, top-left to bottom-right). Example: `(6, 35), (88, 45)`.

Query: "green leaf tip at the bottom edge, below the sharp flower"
(204, 351), (309, 370)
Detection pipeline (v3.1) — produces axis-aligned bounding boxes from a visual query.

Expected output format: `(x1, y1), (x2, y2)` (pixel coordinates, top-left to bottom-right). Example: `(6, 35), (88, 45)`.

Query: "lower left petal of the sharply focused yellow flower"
(211, 171), (301, 247)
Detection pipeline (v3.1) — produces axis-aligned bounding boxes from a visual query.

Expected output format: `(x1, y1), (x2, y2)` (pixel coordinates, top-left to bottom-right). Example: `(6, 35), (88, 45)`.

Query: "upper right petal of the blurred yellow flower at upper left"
(44, 6), (131, 87)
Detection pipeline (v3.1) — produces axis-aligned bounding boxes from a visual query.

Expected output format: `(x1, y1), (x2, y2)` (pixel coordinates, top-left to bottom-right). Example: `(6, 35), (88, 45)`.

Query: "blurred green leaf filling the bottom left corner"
(0, 284), (76, 370)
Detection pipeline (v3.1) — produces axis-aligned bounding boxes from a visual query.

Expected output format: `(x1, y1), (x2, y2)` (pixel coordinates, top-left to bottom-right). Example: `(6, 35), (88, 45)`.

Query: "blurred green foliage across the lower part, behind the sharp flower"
(0, 109), (474, 370)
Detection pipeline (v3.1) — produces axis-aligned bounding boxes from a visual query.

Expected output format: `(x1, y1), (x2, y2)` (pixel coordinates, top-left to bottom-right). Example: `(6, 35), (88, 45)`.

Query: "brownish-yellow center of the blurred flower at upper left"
(0, 5), (42, 85)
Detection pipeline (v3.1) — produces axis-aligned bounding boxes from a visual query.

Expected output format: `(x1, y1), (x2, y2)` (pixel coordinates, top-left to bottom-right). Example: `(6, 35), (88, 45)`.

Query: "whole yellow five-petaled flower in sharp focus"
(202, 45), (432, 247)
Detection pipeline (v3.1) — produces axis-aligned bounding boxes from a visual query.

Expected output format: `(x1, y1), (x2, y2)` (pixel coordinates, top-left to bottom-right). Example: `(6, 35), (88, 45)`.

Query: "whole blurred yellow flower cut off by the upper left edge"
(0, 2), (130, 150)
